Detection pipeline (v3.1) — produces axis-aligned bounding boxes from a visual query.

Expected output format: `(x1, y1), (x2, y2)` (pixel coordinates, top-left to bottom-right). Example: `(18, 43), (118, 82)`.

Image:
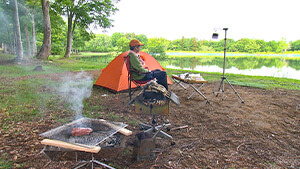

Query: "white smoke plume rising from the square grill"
(59, 72), (93, 119)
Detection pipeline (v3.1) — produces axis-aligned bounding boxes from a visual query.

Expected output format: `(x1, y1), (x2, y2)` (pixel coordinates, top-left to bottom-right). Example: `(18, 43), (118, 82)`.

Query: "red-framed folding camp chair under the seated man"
(124, 55), (150, 100)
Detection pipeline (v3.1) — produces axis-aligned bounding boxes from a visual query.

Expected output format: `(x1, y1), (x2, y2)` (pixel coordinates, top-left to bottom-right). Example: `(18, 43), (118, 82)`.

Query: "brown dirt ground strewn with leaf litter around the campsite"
(0, 71), (300, 168)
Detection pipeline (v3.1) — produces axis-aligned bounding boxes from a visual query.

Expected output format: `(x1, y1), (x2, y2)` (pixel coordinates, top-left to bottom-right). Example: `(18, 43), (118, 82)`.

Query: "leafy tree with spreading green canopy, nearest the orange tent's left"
(52, 0), (119, 58)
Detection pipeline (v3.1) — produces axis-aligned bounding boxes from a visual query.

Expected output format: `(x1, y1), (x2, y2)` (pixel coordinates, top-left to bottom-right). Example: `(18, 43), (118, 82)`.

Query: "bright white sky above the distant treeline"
(93, 0), (300, 42)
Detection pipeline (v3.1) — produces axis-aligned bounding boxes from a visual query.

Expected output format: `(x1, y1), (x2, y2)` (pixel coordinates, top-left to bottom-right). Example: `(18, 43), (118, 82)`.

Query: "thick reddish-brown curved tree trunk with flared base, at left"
(36, 0), (51, 60)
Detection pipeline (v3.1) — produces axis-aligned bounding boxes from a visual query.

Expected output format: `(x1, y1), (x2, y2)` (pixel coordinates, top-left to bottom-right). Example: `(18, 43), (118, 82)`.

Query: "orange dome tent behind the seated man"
(95, 51), (172, 92)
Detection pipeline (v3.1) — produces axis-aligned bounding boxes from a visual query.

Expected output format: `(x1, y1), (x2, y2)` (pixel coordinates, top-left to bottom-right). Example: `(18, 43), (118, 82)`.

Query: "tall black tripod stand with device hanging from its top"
(206, 28), (245, 104)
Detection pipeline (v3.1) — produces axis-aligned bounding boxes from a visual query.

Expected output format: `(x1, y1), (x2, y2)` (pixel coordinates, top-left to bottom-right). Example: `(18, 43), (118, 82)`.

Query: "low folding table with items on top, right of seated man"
(172, 74), (209, 103)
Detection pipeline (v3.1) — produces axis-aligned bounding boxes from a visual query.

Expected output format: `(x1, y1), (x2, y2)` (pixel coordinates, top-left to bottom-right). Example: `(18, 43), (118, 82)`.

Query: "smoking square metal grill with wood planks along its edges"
(40, 118), (132, 169)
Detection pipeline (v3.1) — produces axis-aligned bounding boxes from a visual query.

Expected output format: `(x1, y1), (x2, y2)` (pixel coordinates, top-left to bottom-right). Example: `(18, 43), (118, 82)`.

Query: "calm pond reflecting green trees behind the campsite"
(75, 54), (300, 80)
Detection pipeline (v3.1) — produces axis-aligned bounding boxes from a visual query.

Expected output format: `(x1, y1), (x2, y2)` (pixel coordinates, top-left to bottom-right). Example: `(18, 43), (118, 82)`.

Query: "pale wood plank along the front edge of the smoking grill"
(41, 139), (101, 153)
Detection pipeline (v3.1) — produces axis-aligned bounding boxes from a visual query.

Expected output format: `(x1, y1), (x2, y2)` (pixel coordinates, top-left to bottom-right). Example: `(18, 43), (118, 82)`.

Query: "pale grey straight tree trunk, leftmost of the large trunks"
(14, 0), (23, 61)
